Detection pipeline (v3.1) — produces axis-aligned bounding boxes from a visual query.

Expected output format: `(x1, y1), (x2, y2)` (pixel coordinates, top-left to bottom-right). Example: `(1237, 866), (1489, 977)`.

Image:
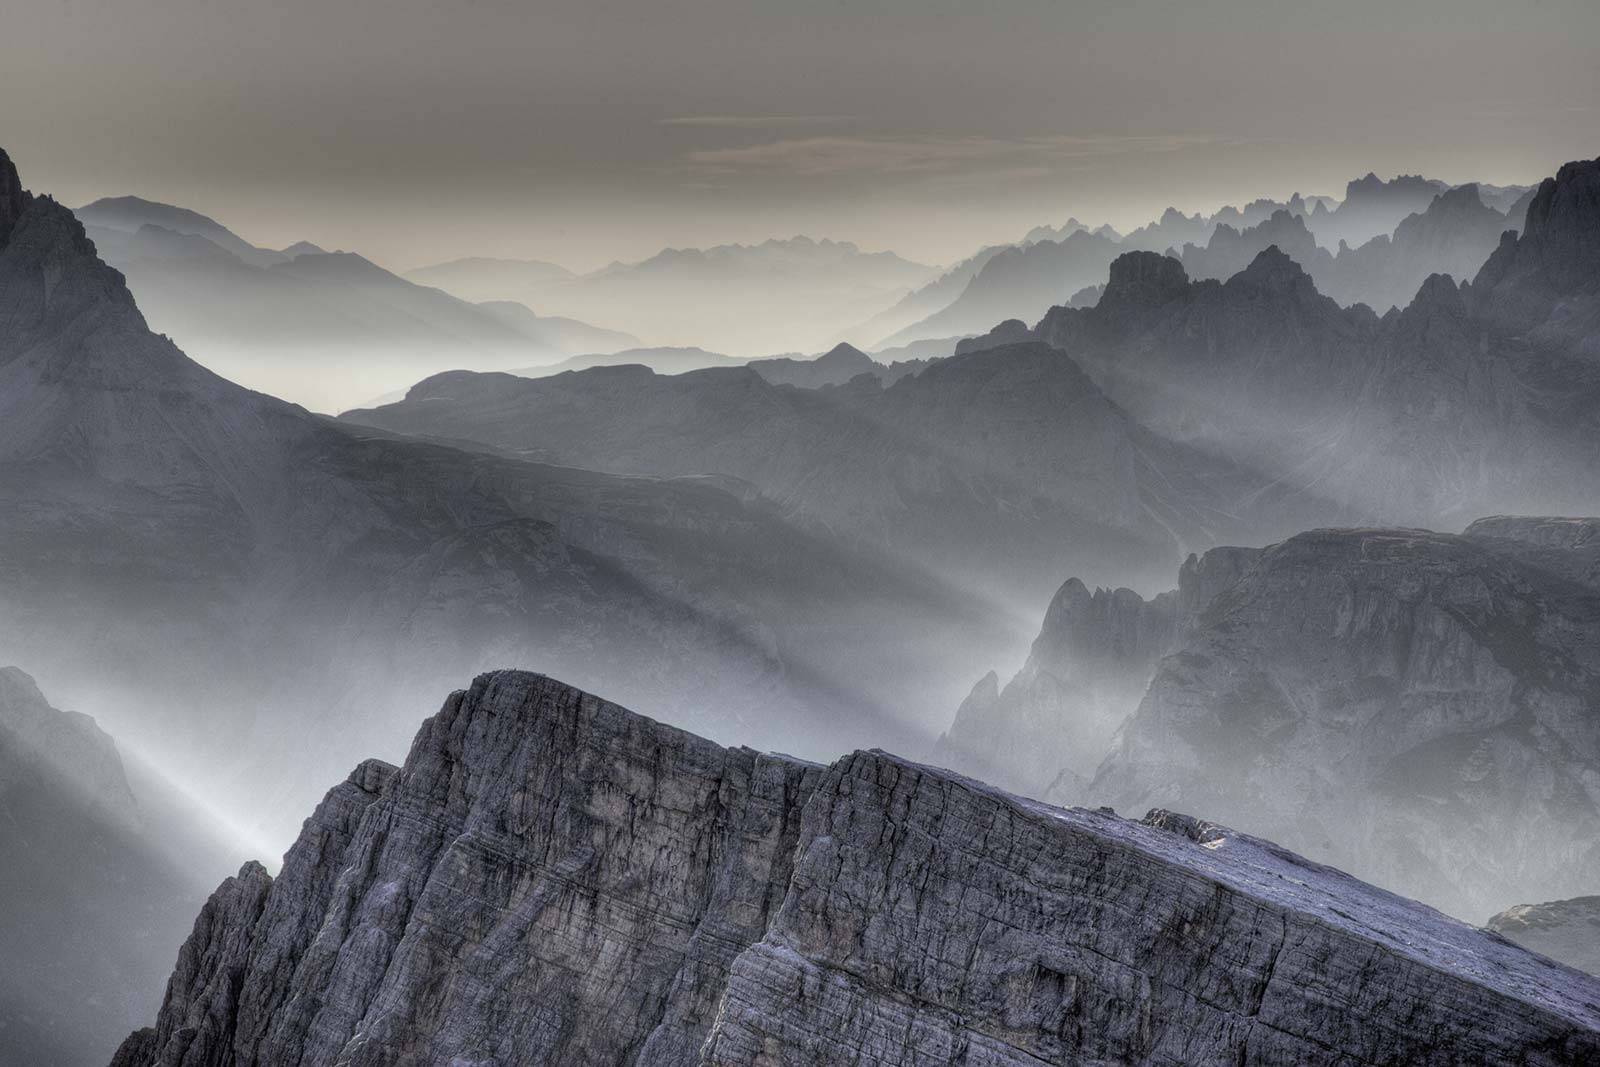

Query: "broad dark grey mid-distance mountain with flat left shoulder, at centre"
(341, 341), (1331, 613)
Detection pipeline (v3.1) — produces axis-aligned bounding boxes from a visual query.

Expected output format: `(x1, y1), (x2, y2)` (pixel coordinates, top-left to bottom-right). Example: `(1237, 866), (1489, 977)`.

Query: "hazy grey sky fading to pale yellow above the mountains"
(0, 0), (1600, 267)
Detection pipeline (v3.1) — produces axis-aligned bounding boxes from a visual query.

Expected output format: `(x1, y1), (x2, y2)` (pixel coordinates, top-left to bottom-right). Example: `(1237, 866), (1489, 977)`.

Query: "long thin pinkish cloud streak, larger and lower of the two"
(683, 134), (1218, 176)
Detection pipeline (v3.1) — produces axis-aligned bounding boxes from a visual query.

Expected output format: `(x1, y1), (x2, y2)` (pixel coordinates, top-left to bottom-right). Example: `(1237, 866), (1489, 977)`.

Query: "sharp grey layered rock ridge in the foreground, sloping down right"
(114, 670), (1600, 1067)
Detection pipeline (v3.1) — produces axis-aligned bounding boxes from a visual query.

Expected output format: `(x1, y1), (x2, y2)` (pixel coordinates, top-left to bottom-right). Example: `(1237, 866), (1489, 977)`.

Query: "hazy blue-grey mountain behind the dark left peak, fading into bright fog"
(77, 191), (635, 411)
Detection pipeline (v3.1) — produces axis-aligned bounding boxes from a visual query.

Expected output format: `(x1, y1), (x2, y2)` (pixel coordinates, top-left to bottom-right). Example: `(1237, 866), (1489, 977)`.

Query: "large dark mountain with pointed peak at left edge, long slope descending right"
(0, 151), (1008, 851)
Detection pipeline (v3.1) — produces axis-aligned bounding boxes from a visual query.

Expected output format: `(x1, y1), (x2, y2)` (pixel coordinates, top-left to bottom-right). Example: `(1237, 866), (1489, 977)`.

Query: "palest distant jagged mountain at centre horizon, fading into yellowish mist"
(464, 237), (938, 358)
